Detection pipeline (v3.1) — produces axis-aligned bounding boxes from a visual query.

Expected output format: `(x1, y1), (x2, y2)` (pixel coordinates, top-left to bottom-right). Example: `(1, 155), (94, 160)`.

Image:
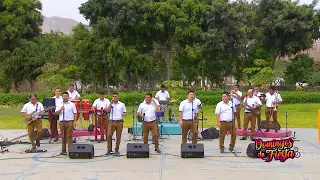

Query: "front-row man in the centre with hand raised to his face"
(137, 93), (161, 153)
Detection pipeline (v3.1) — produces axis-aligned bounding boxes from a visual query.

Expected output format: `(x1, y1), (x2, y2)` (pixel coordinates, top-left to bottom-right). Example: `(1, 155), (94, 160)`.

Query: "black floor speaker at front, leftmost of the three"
(69, 144), (94, 159)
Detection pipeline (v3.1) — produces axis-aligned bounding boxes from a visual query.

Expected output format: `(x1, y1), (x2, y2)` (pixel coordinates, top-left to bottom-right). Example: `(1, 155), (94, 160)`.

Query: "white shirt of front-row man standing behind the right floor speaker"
(179, 99), (198, 120)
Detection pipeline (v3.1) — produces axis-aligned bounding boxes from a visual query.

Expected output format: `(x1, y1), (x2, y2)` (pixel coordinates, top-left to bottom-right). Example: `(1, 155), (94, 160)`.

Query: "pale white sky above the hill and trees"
(41, 0), (320, 24)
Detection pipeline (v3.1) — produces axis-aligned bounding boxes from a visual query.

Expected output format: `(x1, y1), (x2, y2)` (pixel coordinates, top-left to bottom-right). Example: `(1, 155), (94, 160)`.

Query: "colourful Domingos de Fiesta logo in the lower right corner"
(253, 138), (301, 162)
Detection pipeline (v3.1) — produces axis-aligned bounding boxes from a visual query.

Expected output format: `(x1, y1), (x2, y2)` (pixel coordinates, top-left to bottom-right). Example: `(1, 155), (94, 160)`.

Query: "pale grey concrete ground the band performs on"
(0, 129), (320, 180)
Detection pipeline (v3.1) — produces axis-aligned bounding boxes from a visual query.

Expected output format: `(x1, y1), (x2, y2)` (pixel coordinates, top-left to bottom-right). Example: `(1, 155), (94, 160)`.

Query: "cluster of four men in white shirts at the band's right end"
(215, 85), (282, 153)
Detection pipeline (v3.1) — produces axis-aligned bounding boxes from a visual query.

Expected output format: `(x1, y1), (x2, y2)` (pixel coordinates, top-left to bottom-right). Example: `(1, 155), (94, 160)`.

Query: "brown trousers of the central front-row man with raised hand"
(142, 120), (159, 149)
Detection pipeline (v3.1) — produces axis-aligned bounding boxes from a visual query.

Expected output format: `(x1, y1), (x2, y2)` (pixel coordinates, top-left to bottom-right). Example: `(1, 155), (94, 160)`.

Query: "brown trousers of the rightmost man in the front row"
(219, 121), (237, 149)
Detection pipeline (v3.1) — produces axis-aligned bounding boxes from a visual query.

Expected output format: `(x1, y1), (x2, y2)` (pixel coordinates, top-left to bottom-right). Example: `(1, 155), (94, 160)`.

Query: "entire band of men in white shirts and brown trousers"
(21, 84), (282, 155)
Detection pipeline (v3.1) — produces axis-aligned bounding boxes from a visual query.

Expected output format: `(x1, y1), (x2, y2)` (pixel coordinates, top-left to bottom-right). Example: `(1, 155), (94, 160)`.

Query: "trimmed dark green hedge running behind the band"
(0, 91), (320, 106)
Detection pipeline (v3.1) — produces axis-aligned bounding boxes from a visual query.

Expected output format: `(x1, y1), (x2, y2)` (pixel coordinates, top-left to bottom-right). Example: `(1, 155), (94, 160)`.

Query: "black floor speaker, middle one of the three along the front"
(127, 143), (149, 158)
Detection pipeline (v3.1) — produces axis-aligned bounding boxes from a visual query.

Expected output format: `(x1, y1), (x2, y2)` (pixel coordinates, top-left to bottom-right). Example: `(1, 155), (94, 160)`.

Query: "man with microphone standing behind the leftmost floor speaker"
(54, 92), (77, 155)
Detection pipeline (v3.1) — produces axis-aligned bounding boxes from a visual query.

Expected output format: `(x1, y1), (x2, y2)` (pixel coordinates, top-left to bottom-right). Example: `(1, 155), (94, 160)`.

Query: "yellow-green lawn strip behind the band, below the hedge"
(0, 104), (320, 129)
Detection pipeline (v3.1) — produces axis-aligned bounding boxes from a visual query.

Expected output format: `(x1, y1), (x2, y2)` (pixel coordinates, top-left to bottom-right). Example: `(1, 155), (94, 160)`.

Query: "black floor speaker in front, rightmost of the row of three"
(181, 143), (204, 158)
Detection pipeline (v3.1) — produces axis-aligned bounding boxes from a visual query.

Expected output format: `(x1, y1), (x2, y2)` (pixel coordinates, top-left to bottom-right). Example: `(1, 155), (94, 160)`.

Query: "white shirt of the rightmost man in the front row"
(215, 101), (237, 122)
